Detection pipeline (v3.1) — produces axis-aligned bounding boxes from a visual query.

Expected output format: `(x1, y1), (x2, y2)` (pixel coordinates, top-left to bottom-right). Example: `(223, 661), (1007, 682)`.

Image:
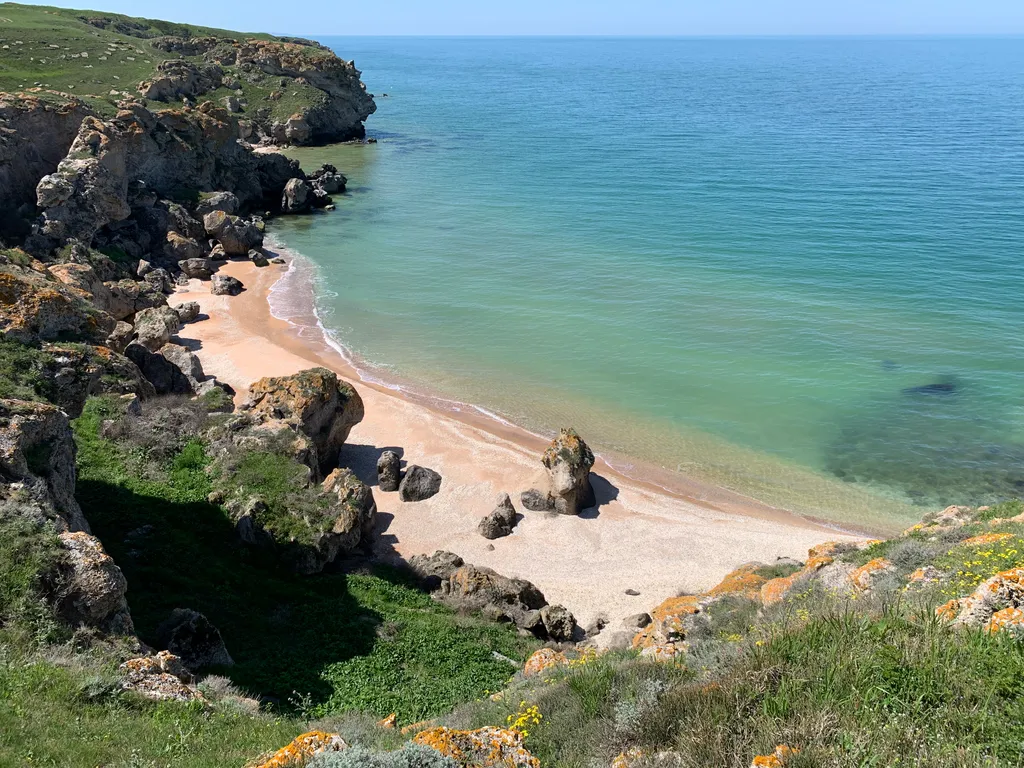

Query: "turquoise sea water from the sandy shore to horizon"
(273, 38), (1024, 519)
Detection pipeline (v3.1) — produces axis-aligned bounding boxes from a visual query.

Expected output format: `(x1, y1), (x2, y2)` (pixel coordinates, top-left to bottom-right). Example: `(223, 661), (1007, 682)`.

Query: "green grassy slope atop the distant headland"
(0, 3), (322, 119)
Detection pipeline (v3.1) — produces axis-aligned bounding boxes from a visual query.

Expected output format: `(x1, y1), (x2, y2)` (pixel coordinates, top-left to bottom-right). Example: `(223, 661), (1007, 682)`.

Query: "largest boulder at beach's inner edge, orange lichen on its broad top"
(242, 368), (364, 477)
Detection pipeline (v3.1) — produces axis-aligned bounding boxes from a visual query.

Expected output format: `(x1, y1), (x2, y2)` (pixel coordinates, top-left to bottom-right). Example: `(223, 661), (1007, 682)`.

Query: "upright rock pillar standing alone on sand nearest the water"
(522, 428), (597, 515)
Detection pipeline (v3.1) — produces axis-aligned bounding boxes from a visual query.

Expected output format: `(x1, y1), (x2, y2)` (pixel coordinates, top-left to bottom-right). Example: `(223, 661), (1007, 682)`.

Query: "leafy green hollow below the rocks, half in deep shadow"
(75, 399), (537, 723)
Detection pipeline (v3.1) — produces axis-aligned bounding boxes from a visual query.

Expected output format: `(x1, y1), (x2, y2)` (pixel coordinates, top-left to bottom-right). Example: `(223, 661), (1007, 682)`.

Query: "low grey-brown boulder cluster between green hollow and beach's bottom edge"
(409, 550), (582, 643)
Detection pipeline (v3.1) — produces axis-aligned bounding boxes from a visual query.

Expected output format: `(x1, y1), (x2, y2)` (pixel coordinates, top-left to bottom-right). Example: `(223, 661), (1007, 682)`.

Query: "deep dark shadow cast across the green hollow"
(76, 480), (387, 709)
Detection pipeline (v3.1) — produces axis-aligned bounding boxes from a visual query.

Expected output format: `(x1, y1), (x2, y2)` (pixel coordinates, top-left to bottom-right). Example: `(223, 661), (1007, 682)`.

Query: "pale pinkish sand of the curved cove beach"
(170, 262), (853, 637)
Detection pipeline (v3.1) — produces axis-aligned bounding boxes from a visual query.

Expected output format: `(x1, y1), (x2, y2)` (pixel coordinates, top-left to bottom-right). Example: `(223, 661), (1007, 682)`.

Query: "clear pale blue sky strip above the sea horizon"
(18, 0), (1024, 36)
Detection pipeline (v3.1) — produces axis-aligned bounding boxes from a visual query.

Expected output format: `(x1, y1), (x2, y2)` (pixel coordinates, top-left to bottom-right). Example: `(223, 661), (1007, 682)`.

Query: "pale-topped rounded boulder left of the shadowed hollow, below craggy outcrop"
(57, 530), (134, 635)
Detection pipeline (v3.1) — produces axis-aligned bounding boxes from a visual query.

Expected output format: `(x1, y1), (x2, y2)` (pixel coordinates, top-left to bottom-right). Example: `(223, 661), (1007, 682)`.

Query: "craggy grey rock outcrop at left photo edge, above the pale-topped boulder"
(0, 399), (89, 532)
